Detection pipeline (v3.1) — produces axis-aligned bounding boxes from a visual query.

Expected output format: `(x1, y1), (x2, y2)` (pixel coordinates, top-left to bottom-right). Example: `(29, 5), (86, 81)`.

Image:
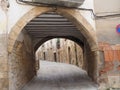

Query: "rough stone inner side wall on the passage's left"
(9, 30), (35, 90)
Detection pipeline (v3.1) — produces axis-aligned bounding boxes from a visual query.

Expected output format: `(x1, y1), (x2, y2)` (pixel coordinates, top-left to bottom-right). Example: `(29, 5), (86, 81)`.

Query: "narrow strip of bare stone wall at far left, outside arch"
(0, 34), (9, 90)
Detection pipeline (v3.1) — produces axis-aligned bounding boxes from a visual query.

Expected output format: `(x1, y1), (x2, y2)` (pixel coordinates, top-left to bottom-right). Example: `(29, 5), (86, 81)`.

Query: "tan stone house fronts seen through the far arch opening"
(36, 38), (83, 68)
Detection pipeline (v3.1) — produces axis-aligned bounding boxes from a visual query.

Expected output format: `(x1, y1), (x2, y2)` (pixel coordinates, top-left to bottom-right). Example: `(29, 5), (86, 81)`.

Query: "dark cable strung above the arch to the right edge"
(16, 0), (120, 19)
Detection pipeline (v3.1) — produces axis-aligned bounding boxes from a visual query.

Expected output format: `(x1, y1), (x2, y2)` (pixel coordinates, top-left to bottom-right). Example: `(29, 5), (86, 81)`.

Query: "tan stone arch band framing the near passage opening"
(8, 7), (99, 80)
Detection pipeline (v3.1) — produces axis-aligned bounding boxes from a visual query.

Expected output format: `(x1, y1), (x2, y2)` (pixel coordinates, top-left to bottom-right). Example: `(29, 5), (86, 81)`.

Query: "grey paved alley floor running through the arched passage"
(22, 61), (97, 90)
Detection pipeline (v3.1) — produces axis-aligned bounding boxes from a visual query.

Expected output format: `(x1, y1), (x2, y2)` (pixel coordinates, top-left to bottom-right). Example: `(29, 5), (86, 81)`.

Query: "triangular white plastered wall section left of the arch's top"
(8, 0), (33, 32)
